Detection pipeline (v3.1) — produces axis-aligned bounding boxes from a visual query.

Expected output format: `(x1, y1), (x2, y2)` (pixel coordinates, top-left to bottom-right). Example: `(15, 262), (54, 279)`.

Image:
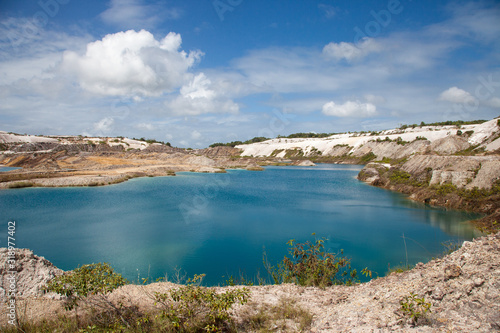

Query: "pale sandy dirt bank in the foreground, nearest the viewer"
(0, 233), (500, 332)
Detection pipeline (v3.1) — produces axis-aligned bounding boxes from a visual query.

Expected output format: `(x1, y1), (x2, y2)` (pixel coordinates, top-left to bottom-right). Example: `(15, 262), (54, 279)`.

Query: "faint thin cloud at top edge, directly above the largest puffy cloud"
(100, 0), (180, 29)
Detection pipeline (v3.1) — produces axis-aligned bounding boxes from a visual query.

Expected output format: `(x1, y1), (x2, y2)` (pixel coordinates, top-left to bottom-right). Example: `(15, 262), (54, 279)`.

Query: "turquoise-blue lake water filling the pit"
(0, 164), (478, 285)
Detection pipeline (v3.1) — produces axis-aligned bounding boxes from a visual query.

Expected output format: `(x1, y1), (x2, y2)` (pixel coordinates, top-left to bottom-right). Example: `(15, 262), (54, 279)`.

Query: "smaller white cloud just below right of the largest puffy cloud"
(165, 73), (239, 116)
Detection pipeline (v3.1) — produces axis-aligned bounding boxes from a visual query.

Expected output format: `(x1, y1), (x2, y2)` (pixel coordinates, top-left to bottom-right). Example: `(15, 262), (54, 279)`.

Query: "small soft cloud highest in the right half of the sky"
(323, 38), (381, 61)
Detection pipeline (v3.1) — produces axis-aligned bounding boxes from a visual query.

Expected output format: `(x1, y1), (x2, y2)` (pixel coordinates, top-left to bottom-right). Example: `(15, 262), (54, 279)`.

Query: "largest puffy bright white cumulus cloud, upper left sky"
(62, 30), (202, 97)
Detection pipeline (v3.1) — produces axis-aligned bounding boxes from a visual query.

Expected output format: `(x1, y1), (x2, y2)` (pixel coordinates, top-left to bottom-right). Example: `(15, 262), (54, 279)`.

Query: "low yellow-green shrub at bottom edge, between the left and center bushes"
(154, 275), (250, 332)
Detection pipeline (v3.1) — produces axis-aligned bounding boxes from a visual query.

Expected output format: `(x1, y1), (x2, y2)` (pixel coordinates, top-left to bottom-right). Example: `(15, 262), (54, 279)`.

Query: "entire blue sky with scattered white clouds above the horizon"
(0, 0), (500, 148)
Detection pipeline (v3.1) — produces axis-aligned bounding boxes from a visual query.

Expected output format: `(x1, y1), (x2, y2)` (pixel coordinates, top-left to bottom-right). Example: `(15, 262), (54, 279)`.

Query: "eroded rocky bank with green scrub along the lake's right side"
(358, 155), (500, 232)
